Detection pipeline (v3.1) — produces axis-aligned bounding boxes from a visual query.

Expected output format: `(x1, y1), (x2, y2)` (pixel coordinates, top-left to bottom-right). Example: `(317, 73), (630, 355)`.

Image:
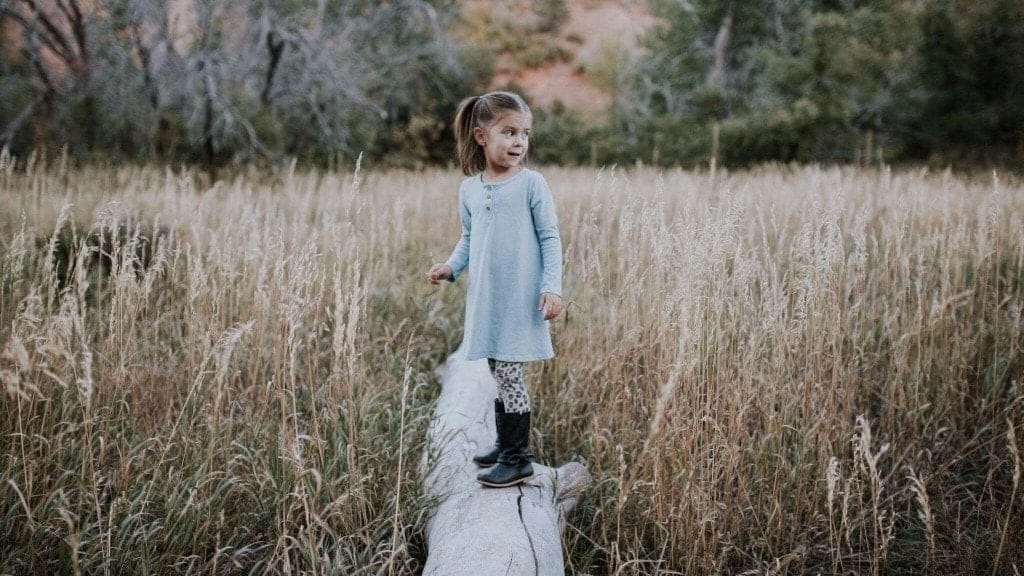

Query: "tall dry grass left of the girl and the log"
(0, 154), (458, 574)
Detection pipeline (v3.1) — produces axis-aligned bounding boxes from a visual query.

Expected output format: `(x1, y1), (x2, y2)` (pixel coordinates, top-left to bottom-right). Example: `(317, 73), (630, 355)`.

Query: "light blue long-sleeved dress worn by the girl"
(445, 168), (562, 362)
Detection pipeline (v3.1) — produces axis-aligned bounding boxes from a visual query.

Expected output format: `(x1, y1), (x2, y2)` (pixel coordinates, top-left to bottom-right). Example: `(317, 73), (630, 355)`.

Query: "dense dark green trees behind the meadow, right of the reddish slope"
(577, 0), (1024, 168)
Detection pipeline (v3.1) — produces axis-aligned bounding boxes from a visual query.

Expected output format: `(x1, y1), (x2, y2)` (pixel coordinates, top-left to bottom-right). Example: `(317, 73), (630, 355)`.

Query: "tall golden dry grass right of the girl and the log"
(537, 163), (1024, 574)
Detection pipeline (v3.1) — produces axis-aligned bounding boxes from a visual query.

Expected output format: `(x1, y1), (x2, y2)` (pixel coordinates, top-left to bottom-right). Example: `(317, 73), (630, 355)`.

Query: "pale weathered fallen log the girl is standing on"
(423, 352), (591, 576)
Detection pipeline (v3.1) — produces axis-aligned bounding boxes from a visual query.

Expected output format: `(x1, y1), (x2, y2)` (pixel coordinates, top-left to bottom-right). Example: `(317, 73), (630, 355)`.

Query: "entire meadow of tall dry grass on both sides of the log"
(0, 154), (1024, 575)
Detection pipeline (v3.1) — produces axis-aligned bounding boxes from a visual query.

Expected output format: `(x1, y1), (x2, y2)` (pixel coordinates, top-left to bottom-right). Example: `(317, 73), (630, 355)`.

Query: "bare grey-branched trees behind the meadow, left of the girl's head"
(0, 0), (474, 174)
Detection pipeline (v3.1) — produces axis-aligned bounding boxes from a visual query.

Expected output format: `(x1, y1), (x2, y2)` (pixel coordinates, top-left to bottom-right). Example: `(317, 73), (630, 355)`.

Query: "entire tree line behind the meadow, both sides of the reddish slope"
(0, 0), (1024, 169)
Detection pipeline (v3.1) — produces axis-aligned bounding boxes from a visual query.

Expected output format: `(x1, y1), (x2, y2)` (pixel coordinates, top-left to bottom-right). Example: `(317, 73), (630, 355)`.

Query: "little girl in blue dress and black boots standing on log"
(429, 92), (562, 487)
